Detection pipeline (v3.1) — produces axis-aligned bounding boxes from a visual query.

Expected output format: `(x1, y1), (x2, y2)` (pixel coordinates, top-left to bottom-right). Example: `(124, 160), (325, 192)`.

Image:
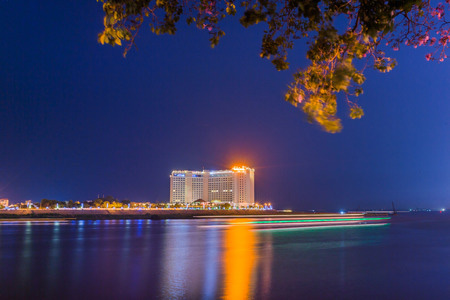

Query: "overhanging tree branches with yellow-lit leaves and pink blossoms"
(97, 0), (450, 133)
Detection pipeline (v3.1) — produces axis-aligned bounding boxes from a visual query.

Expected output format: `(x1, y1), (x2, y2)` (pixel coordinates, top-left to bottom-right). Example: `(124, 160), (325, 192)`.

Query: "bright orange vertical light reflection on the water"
(223, 220), (258, 300)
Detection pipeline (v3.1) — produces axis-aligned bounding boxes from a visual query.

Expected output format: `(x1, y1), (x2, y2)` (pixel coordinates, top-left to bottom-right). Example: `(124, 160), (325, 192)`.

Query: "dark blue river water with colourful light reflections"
(0, 213), (450, 299)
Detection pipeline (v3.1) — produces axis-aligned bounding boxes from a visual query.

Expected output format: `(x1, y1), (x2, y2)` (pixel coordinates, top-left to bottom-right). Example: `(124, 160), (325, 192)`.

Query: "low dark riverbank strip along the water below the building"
(0, 209), (306, 220)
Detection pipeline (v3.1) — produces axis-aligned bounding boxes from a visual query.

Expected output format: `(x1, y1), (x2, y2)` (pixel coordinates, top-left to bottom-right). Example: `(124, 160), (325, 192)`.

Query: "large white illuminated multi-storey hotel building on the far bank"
(170, 166), (255, 206)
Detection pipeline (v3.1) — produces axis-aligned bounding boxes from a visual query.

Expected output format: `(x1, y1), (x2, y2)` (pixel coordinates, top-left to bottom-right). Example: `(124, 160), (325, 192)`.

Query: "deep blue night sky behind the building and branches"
(0, 0), (450, 210)
